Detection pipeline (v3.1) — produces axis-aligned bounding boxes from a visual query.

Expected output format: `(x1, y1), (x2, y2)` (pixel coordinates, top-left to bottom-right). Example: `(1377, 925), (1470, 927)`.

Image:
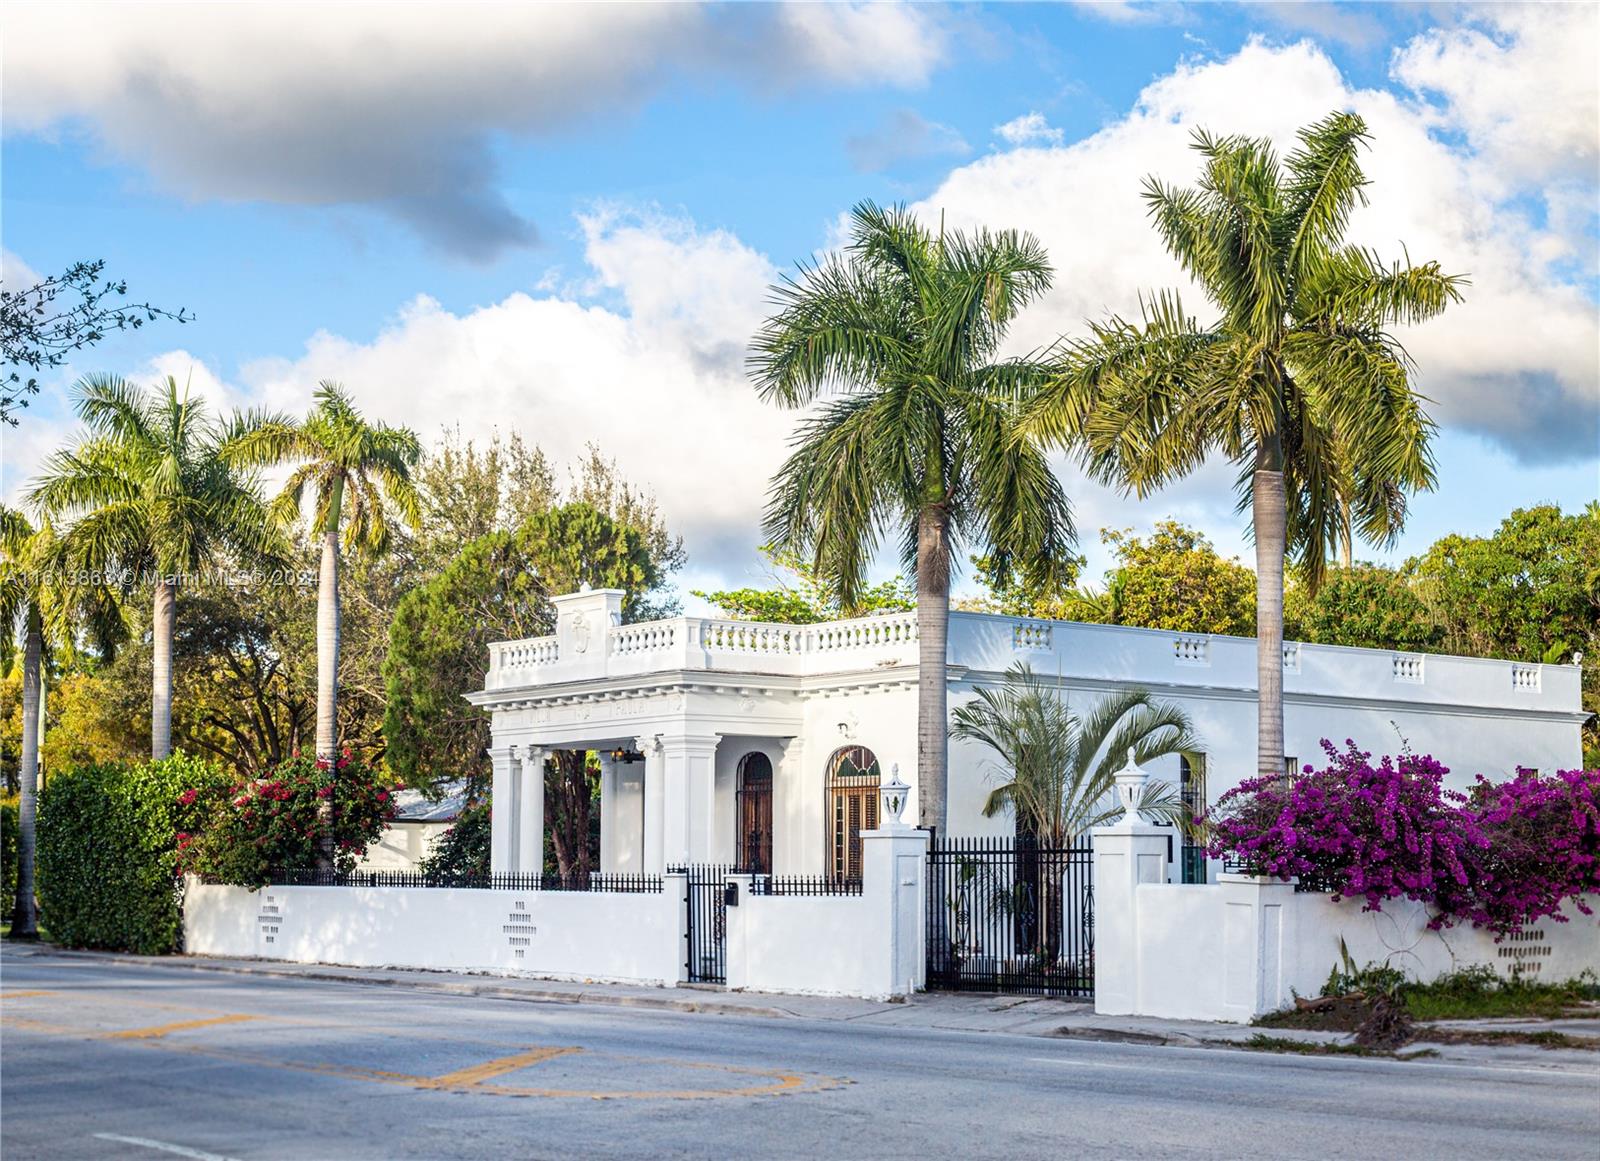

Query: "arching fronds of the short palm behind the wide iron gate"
(950, 664), (1198, 846)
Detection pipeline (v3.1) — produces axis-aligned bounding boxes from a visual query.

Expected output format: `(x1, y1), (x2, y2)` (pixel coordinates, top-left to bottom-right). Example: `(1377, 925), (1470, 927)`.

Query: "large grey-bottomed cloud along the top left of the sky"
(3, 0), (944, 259)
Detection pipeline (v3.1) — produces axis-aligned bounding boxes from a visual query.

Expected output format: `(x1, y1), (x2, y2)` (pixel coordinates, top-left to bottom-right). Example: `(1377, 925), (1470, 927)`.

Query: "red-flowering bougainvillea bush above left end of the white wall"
(178, 750), (395, 888)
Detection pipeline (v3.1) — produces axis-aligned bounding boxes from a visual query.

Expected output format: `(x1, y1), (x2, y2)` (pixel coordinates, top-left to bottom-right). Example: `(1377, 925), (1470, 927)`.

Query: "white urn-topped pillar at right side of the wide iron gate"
(1091, 750), (1168, 1015)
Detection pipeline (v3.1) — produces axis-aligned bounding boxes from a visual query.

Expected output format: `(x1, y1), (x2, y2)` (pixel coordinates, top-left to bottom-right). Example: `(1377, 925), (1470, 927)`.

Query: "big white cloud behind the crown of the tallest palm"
(920, 28), (1600, 461)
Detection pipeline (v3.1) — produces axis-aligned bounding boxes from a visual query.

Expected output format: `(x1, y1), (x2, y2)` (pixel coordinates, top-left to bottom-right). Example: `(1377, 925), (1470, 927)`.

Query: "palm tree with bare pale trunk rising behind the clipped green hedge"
(27, 376), (280, 758)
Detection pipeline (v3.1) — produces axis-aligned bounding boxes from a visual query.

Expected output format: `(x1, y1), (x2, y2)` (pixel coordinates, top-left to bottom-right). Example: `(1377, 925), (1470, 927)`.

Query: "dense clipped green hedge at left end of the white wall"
(38, 755), (227, 955)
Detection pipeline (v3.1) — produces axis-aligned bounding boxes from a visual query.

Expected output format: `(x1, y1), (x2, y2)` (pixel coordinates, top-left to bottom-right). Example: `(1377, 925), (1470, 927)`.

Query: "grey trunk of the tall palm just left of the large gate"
(917, 505), (950, 836)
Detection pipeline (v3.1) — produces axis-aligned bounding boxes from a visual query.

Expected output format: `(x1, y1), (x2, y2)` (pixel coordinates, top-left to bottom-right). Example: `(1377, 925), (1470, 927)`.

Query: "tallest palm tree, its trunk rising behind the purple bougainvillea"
(1026, 112), (1462, 776)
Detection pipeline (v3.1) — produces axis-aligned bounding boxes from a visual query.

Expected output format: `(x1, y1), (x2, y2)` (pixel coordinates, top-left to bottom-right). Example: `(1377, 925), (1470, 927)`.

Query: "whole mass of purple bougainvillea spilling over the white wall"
(1205, 740), (1600, 934)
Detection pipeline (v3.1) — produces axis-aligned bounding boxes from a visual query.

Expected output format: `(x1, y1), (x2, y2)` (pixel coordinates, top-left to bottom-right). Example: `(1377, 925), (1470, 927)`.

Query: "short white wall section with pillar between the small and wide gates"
(726, 830), (928, 999)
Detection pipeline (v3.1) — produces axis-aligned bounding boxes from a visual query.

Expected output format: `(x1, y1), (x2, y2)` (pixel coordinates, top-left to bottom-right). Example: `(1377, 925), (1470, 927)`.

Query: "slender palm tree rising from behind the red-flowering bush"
(224, 382), (422, 865)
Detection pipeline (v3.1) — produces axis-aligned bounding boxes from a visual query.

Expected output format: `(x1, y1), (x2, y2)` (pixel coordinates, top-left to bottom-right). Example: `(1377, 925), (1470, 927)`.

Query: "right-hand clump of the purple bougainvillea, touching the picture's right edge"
(1437, 769), (1600, 931)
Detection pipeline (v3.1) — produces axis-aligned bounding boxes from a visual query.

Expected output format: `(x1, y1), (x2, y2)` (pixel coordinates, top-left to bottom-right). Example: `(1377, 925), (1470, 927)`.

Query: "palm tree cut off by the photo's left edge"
(0, 504), (122, 939)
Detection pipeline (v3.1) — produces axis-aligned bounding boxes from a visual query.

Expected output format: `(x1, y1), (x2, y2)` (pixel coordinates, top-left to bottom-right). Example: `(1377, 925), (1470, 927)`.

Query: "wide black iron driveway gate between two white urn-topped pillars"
(928, 838), (1094, 996)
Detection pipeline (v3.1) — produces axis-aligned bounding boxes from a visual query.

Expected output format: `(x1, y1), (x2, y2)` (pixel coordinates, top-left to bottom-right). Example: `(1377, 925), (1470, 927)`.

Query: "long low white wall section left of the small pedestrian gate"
(184, 875), (685, 983)
